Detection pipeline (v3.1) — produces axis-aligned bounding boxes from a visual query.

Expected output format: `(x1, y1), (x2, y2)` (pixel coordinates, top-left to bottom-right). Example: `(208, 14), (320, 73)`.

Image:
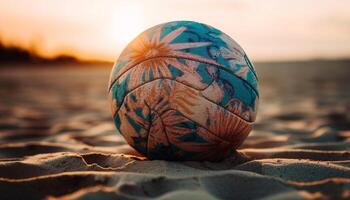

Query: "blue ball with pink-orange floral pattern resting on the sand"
(109, 21), (259, 161)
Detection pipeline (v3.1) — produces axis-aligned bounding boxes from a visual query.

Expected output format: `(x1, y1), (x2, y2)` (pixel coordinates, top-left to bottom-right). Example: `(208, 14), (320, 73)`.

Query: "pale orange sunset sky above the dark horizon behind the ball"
(0, 0), (350, 61)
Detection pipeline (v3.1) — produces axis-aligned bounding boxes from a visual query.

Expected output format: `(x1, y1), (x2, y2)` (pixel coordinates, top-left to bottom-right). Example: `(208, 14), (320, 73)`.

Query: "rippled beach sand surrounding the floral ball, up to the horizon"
(0, 63), (350, 200)
